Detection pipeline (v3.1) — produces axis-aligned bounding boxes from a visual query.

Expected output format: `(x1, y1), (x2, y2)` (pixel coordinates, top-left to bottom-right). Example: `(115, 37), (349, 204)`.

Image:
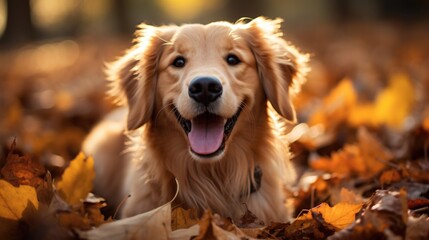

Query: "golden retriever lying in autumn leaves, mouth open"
(83, 17), (307, 222)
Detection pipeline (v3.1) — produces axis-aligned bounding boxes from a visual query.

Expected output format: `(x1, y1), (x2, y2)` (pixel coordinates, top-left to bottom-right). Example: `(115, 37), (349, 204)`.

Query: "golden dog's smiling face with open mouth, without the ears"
(158, 23), (263, 160)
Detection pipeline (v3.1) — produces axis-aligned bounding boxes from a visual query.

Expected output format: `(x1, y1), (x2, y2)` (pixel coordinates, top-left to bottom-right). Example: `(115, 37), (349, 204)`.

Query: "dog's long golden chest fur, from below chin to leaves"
(123, 116), (293, 221)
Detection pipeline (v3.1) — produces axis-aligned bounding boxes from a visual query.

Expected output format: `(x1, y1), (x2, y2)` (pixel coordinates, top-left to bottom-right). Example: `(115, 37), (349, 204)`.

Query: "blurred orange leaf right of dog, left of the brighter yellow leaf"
(308, 78), (357, 128)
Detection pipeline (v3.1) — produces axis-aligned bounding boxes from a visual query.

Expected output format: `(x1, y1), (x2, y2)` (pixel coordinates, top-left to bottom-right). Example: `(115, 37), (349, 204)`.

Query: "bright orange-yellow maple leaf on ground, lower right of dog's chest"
(296, 202), (362, 230)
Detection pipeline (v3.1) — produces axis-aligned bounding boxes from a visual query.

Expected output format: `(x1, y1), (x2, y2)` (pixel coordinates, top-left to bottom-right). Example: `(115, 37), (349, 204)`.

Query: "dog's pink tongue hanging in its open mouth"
(188, 114), (224, 155)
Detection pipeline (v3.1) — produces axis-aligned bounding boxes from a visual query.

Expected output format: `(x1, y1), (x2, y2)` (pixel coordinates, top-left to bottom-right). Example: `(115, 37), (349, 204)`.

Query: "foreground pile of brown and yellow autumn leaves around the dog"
(0, 69), (429, 239)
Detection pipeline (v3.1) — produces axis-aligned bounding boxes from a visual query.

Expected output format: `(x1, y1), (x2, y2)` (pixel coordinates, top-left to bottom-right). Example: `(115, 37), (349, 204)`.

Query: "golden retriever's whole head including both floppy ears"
(108, 17), (307, 161)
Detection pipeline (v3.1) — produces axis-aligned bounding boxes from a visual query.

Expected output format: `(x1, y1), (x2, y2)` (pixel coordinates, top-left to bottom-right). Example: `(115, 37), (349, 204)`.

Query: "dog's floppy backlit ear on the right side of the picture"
(238, 17), (308, 121)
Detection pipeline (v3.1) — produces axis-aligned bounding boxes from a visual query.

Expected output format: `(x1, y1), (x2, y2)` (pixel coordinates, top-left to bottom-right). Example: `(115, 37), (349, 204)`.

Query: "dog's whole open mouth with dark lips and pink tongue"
(174, 107), (242, 158)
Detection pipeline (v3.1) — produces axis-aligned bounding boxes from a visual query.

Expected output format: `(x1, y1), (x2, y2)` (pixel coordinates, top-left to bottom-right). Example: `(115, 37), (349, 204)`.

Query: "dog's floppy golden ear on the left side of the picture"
(106, 24), (175, 130)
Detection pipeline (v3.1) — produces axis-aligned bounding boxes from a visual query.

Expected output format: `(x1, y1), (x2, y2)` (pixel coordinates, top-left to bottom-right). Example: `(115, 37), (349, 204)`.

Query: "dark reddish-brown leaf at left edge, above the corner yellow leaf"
(1, 140), (46, 187)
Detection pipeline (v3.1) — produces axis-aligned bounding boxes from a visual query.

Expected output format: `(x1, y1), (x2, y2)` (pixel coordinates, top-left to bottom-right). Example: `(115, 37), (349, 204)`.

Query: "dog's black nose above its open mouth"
(188, 77), (223, 106)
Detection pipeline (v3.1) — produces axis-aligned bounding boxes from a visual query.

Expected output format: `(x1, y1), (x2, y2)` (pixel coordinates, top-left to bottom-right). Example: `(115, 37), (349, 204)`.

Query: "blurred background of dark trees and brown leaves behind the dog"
(0, 0), (429, 173)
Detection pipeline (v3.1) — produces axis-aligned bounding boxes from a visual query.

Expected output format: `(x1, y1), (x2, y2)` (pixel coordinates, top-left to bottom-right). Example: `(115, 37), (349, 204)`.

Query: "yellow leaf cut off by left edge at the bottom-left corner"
(0, 179), (39, 239)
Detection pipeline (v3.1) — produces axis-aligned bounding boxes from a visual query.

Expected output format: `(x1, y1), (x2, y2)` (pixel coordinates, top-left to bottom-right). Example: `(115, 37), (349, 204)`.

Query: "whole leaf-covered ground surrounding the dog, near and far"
(0, 24), (429, 239)
